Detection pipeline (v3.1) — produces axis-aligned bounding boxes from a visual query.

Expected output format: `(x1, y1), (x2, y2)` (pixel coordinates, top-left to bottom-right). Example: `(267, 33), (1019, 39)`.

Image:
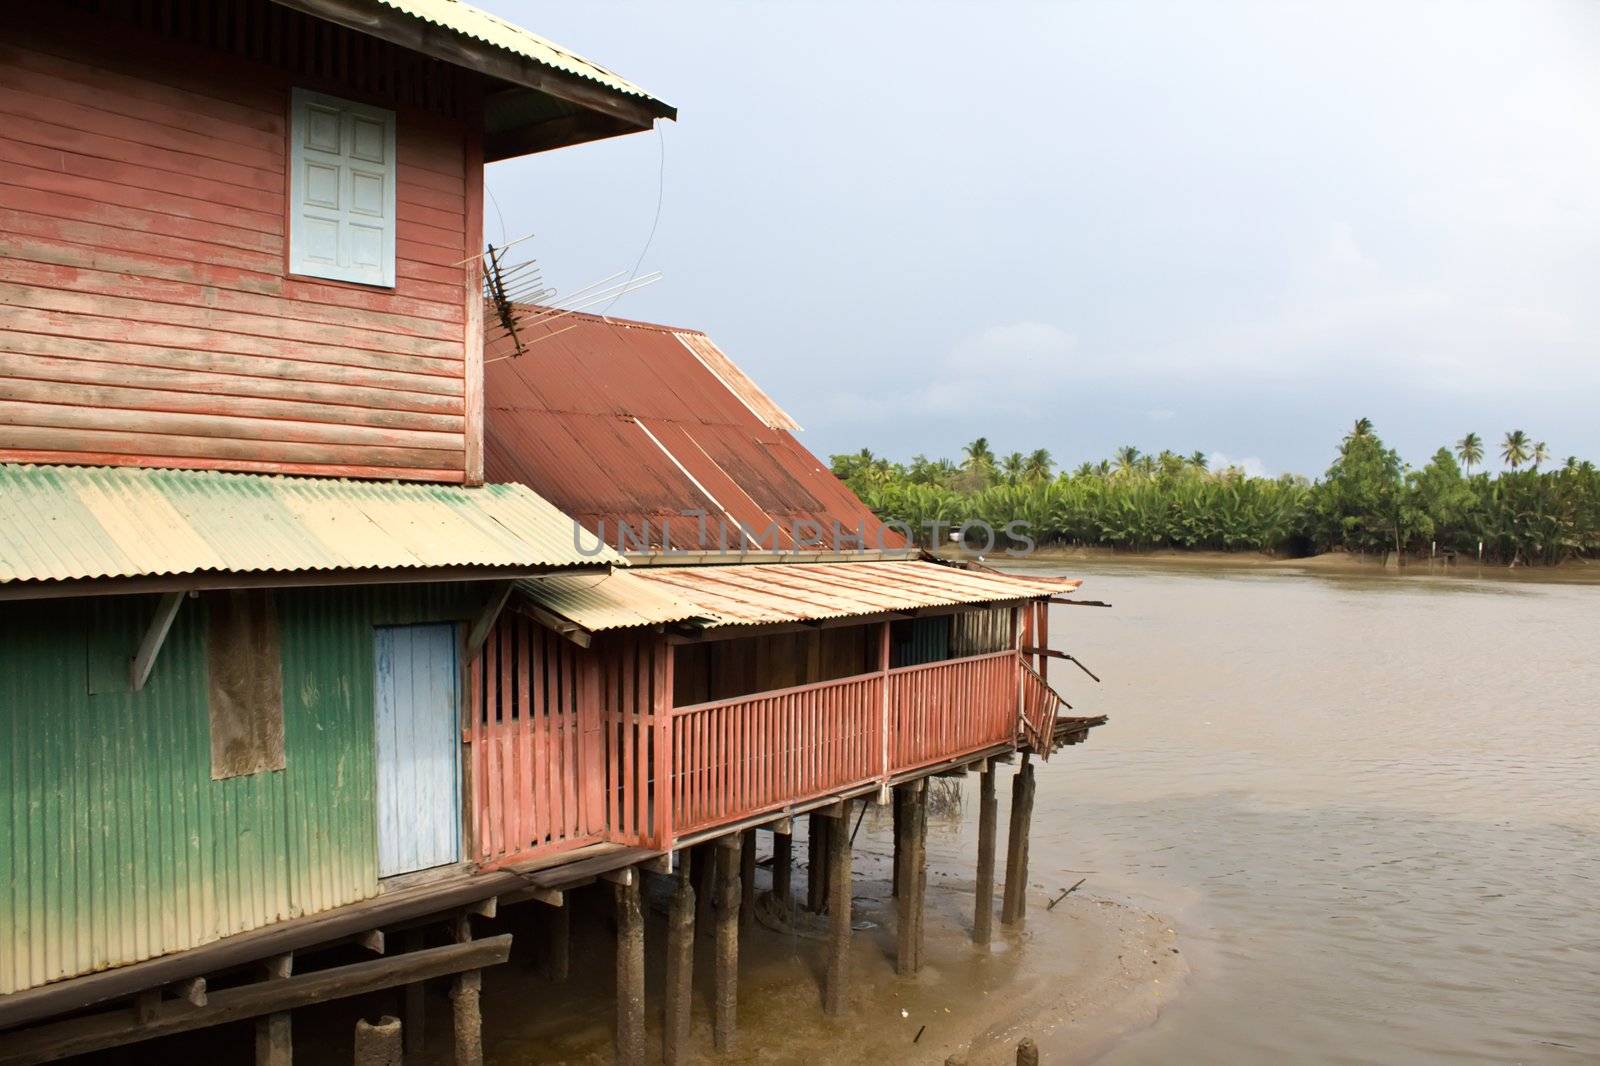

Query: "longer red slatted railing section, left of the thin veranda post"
(672, 674), (883, 836)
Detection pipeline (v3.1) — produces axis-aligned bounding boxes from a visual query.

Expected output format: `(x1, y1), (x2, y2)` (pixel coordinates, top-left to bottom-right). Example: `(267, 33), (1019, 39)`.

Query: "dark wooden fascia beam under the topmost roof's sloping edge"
(275, 0), (677, 130)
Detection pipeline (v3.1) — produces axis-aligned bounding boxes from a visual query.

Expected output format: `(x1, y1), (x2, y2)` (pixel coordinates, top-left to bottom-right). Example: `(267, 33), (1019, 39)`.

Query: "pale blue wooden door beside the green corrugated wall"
(374, 626), (461, 877)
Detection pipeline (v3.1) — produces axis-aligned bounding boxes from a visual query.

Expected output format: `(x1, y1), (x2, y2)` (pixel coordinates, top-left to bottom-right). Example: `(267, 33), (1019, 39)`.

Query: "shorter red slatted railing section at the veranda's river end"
(888, 650), (1018, 773)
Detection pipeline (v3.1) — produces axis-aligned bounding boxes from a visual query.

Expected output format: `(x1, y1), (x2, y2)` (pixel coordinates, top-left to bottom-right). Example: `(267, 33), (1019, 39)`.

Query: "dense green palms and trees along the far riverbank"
(832, 418), (1600, 565)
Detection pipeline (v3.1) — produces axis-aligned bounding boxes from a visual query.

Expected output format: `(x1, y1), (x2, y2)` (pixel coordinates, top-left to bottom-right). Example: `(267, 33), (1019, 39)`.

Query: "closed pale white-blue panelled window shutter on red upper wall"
(290, 90), (395, 287)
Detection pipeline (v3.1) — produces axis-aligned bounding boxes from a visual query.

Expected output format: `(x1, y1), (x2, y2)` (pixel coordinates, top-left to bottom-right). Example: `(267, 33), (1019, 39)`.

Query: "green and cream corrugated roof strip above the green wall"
(0, 464), (622, 586)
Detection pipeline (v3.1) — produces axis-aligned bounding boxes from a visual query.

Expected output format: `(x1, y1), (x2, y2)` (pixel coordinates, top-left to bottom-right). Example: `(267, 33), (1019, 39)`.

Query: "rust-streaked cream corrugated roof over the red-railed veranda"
(520, 560), (1080, 632)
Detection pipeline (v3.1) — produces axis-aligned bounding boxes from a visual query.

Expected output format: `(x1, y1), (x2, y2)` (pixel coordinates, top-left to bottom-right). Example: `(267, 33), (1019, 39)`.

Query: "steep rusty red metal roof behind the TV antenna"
(483, 307), (907, 552)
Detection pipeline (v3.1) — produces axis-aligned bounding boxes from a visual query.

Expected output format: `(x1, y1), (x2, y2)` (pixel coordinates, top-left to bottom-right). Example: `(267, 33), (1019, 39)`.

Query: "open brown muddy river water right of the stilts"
(998, 563), (1600, 1066)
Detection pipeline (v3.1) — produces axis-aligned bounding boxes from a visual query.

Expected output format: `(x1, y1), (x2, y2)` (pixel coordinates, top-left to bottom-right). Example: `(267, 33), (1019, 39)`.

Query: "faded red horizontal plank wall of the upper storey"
(0, 26), (482, 482)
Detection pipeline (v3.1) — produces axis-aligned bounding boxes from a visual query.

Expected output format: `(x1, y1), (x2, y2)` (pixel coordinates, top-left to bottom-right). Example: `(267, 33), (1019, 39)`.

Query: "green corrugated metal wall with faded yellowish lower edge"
(0, 586), (485, 992)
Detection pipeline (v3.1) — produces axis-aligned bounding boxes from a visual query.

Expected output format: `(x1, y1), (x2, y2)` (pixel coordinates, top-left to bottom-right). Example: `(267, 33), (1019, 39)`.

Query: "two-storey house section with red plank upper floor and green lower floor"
(0, 0), (674, 1063)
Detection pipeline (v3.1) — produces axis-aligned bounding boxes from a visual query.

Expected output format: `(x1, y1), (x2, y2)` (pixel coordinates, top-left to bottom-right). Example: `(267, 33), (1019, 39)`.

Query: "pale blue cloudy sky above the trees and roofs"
(478, 0), (1600, 475)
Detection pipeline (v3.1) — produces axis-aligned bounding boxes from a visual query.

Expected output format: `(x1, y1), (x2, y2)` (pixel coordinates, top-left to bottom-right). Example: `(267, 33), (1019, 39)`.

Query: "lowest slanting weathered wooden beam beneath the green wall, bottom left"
(0, 935), (510, 1066)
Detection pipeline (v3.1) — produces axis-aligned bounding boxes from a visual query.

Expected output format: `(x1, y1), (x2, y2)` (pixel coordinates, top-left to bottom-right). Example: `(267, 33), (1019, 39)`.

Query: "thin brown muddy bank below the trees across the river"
(939, 544), (1600, 584)
